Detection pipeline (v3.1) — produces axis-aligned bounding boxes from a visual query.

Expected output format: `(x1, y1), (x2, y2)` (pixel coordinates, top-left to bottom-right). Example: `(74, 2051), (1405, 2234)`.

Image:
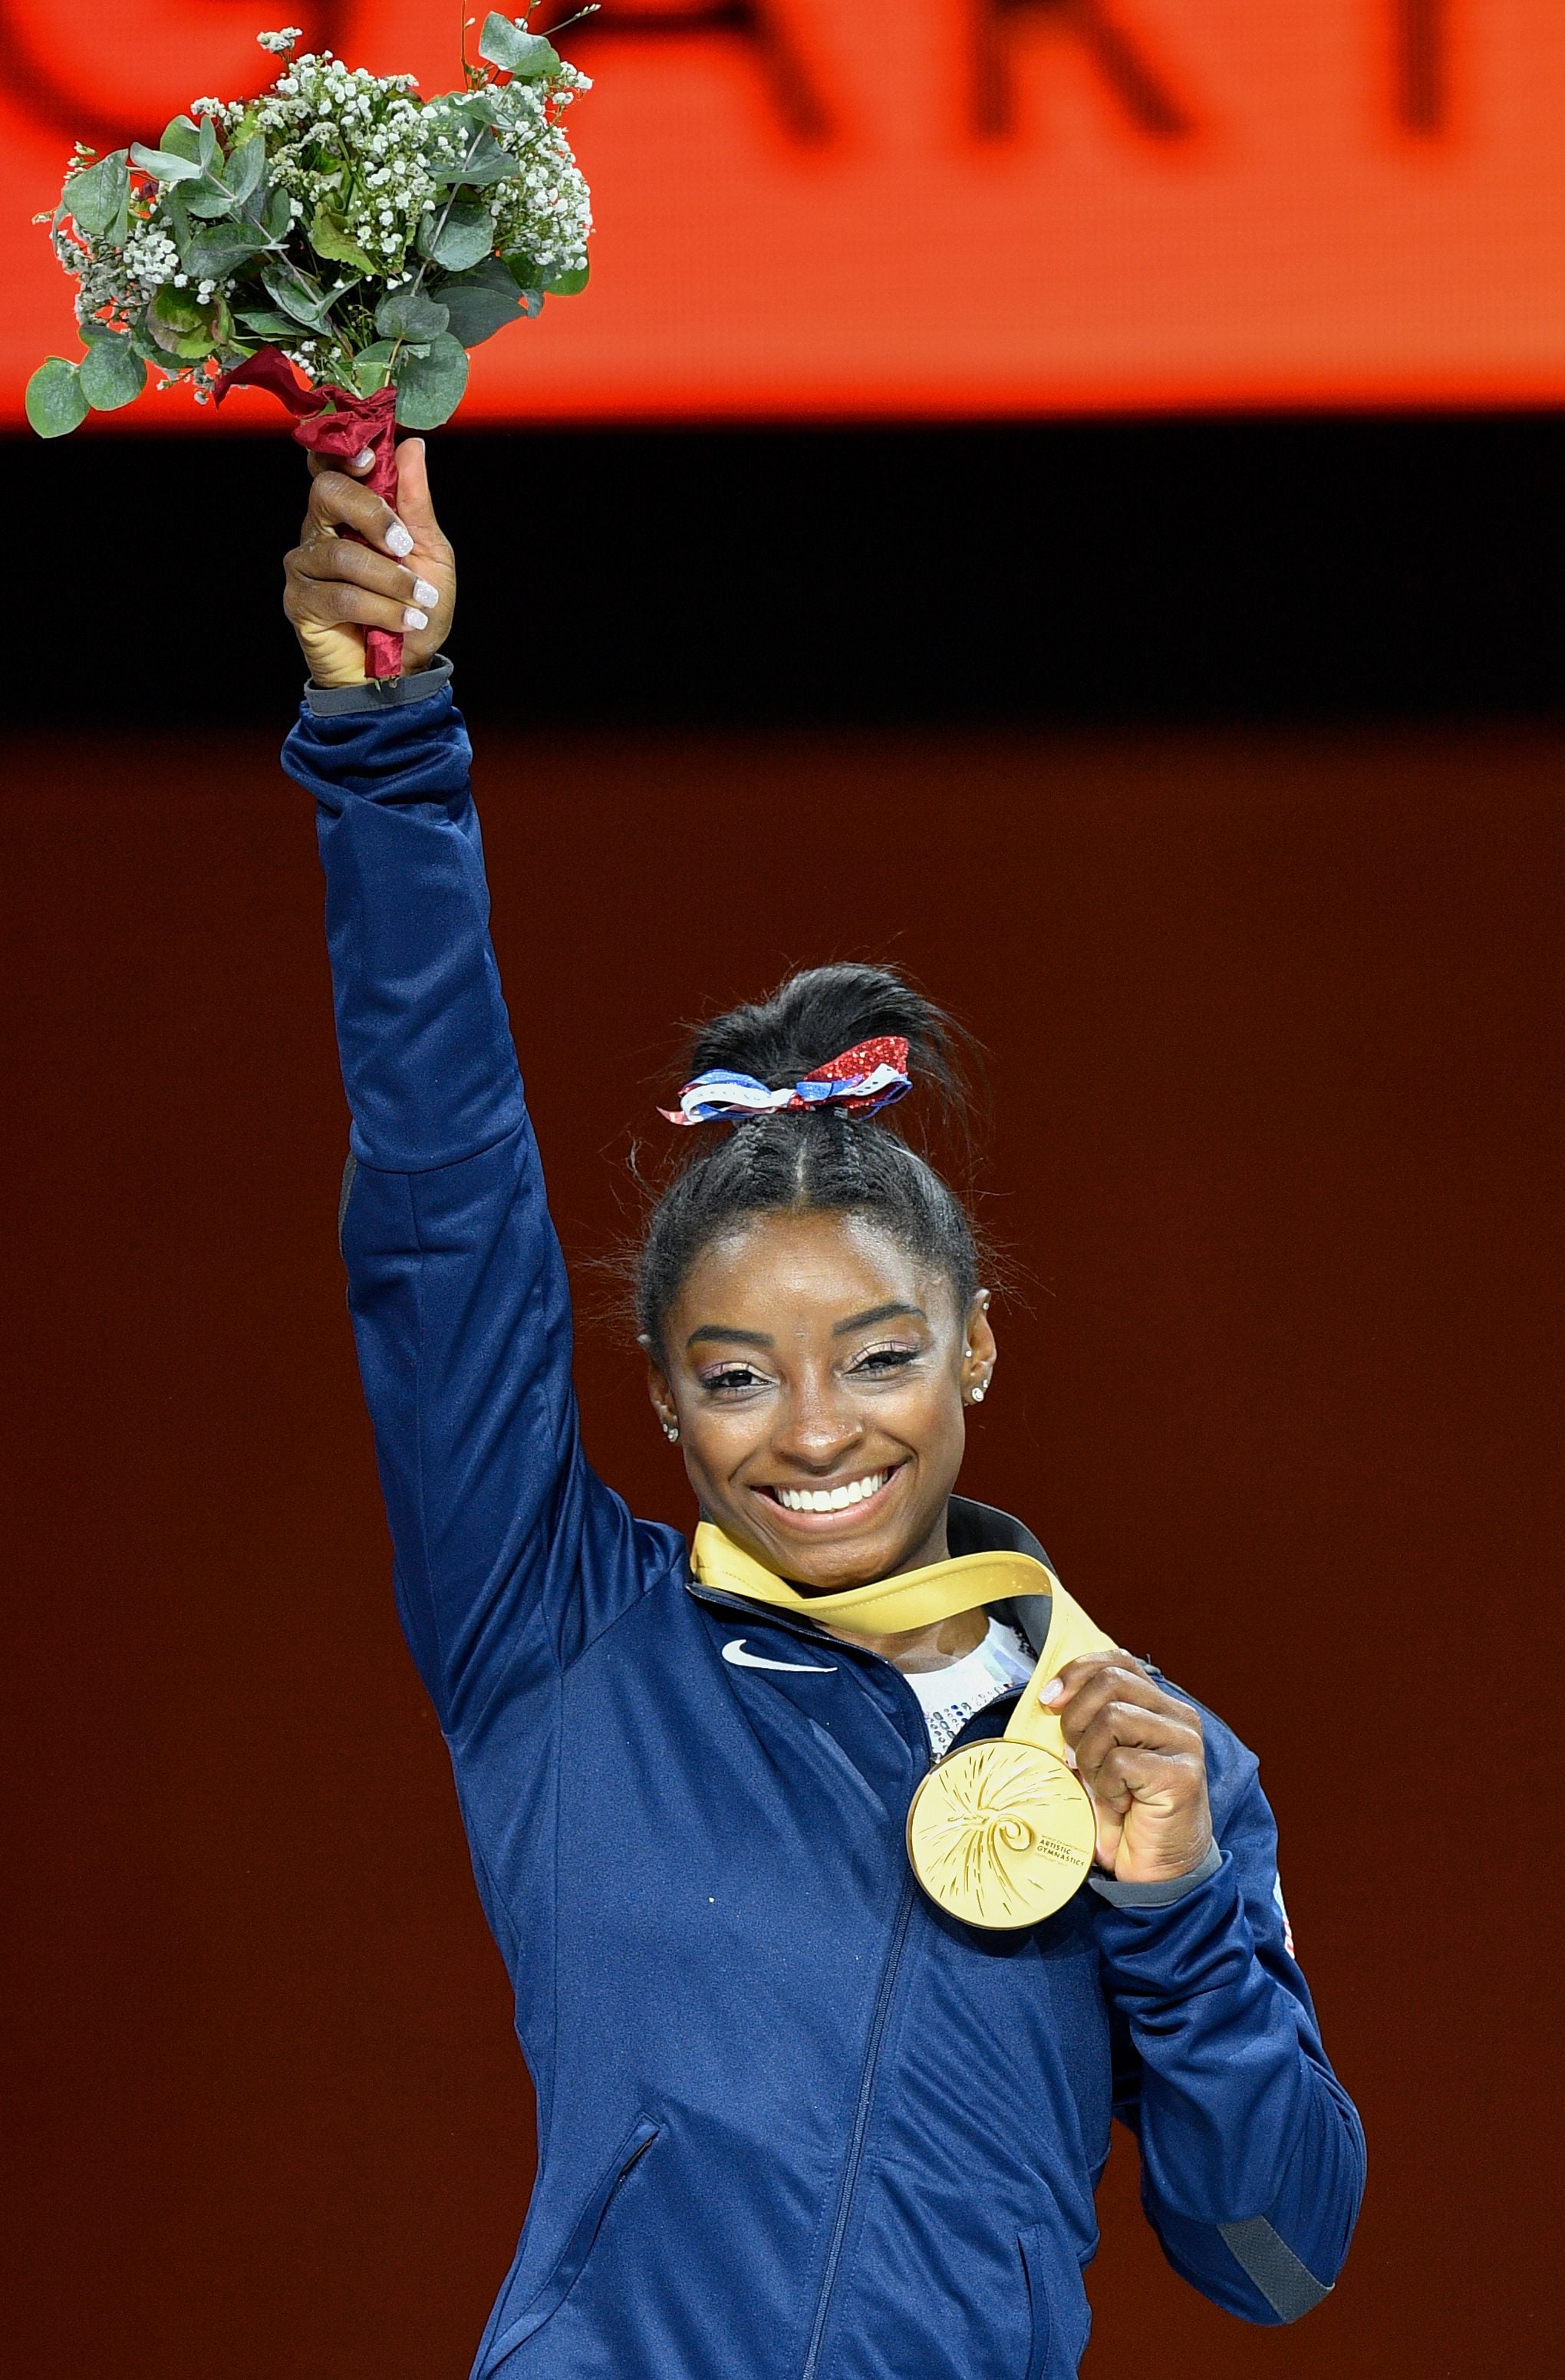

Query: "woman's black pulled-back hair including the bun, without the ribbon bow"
(635, 964), (977, 1352)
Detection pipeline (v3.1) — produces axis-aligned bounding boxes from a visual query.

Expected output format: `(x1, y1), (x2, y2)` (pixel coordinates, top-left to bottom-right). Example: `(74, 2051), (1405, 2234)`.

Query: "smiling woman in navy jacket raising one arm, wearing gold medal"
(275, 440), (1362, 2380)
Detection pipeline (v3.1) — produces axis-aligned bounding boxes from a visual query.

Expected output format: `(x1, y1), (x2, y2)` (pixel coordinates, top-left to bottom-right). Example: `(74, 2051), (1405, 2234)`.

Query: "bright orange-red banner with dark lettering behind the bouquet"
(0, 0), (1565, 428)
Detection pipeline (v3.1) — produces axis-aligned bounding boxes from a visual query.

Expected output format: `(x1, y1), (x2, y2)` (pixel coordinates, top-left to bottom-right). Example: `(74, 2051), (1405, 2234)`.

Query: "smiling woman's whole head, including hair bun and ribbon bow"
(638, 966), (994, 1608)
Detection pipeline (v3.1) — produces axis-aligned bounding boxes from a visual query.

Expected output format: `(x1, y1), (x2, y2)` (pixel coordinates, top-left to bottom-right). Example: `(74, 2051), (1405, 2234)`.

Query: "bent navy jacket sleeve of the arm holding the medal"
(1099, 1721), (1366, 2323)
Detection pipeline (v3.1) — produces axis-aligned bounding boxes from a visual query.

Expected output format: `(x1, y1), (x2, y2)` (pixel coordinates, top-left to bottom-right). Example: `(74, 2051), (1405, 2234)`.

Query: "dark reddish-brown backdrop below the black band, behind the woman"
(2, 726), (1565, 2380)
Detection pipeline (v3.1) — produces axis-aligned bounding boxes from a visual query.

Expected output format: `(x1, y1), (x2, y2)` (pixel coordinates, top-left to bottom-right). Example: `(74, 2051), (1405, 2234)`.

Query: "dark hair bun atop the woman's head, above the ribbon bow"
(687, 961), (964, 1109)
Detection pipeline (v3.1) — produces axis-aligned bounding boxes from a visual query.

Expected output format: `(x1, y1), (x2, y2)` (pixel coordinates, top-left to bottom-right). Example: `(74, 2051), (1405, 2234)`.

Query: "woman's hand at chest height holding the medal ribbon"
(1039, 1650), (1213, 1885)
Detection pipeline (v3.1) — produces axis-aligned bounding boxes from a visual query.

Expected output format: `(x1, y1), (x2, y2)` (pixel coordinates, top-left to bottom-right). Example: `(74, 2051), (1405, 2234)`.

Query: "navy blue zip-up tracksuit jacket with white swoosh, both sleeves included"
(285, 674), (1362, 2380)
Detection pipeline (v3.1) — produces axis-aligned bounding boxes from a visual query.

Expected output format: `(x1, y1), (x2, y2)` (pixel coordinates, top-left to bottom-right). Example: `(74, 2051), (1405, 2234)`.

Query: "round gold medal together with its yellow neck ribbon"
(692, 1521), (1115, 1928)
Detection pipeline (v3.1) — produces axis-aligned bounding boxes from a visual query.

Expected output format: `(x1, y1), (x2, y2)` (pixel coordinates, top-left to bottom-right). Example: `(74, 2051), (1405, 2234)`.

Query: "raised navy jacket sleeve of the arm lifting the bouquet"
(283, 687), (680, 1742)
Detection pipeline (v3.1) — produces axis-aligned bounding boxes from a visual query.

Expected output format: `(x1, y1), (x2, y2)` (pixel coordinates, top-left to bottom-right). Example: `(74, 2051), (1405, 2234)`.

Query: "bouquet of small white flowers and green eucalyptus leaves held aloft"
(26, 7), (592, 676)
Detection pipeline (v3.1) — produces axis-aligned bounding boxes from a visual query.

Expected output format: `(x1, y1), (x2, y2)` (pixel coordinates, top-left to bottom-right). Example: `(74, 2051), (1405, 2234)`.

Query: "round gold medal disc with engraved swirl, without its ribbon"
(906, 1735), (1096, 1928)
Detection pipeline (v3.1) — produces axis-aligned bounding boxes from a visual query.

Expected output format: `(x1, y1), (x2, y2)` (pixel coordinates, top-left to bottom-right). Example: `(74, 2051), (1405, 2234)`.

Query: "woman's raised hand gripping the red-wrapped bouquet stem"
(283, 438), (456, 685)
